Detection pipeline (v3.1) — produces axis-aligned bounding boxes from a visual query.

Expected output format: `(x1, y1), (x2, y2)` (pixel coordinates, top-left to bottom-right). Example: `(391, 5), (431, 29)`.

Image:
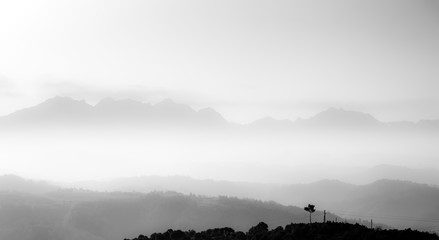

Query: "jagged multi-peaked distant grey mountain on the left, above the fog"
(0, 97), (227, 127)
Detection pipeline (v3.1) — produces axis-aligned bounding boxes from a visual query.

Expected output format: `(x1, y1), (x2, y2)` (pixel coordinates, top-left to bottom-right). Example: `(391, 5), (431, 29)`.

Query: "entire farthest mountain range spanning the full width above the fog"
(0, 97), (439, 131)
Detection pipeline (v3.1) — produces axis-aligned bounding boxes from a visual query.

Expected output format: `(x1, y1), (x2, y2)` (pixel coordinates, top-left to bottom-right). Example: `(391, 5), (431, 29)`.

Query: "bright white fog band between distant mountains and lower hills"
(0, 129), (439, 183)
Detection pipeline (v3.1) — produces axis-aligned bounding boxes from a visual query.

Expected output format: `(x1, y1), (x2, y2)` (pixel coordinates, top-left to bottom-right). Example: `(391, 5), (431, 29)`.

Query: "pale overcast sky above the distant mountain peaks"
(0, 0), (439, 122)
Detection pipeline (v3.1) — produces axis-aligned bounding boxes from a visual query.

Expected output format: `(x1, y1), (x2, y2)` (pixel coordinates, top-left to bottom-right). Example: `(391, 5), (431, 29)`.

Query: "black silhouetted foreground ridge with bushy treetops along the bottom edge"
(124, 222), (439, 240)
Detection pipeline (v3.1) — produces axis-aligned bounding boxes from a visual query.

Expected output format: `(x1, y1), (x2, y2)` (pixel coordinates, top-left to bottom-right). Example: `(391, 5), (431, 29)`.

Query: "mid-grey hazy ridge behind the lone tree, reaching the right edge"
(64, 174), (439, 231)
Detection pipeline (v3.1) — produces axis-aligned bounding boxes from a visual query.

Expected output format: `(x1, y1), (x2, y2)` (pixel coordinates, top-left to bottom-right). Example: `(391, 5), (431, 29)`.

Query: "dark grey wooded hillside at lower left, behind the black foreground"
(0, 189), (335, 240)
